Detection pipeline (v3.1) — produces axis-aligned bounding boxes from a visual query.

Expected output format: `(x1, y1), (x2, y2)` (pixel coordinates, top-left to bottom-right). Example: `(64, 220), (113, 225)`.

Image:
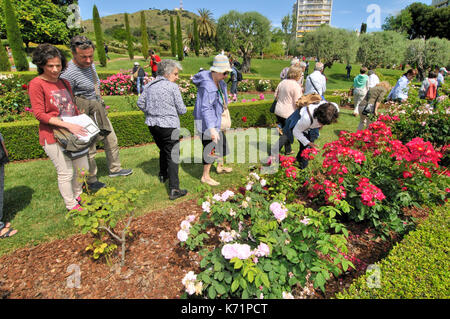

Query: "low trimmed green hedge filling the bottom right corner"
(336, 203), (450, 299)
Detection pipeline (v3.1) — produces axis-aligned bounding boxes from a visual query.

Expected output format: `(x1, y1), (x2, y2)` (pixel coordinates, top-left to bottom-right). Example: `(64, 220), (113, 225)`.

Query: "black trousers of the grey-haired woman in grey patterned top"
(148, 126), (180, 189)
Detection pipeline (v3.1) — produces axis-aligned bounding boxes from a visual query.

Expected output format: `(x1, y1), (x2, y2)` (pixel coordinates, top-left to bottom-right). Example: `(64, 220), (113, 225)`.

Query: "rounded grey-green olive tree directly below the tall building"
(303, 24), (358, 68)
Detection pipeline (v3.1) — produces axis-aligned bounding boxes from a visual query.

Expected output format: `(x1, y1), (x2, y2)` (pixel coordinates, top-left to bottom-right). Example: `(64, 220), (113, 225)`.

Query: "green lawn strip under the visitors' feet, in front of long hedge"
(0, 110), (358, 255)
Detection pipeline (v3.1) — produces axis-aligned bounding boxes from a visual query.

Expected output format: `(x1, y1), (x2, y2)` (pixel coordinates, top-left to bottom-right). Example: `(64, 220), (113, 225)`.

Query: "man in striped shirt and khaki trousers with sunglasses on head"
(61, 35), (133, 190)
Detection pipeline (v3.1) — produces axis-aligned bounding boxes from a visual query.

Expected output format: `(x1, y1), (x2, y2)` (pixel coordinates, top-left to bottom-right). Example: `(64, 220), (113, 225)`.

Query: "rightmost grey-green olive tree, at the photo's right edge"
(405, 38), (450, 80)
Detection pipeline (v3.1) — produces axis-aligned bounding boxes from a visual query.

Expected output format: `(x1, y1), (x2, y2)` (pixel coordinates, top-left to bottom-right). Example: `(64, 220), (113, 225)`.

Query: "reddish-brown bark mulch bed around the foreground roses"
(0, 200), (425, 299)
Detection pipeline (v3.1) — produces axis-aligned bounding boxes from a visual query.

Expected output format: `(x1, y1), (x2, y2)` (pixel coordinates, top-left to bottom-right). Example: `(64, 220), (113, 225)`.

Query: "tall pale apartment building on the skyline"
(294, 0), (333, 38)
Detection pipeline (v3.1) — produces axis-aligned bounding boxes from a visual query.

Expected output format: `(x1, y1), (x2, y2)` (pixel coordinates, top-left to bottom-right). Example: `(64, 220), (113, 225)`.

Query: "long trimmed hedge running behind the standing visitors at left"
(0, 101), (276, 161)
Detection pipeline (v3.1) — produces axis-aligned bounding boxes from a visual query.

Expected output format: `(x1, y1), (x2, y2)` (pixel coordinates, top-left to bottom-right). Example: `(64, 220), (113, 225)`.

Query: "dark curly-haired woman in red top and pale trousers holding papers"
(28, 44), (89, 210)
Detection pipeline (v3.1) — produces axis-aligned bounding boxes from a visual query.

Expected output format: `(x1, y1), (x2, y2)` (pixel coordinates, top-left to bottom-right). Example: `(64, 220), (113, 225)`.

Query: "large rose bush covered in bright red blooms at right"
(302, 115), (449, 237)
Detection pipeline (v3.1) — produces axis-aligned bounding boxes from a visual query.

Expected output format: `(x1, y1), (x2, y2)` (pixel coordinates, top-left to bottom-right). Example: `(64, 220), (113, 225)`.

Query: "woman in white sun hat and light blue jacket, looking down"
(192, 54), (232, 186)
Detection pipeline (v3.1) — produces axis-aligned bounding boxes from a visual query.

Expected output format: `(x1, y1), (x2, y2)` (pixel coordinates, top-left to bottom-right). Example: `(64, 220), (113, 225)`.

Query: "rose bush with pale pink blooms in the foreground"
(179, 173), (353, 298)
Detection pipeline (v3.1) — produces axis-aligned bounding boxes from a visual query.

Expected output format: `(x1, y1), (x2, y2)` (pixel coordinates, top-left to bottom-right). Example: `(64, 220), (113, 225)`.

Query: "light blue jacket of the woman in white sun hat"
(192, 71), (228, 133)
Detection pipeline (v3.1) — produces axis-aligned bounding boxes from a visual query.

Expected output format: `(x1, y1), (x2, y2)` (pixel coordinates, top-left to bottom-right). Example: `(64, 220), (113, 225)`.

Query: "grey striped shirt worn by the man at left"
(60, 60), (100, 100)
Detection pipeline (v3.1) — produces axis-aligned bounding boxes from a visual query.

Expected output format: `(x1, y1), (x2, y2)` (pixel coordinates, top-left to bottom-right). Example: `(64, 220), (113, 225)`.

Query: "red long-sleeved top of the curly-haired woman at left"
(28, 77), (79, 146)
